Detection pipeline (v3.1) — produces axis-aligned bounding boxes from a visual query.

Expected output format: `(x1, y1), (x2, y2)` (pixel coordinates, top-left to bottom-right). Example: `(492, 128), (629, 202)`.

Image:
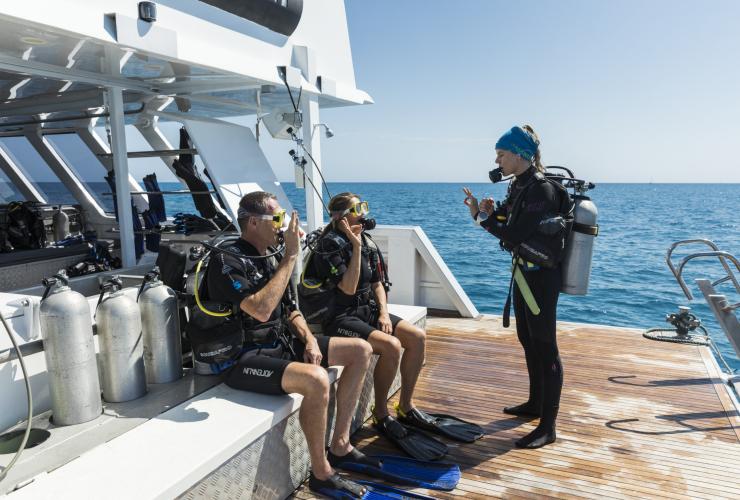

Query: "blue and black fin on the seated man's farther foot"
(328, 449), (460, 491)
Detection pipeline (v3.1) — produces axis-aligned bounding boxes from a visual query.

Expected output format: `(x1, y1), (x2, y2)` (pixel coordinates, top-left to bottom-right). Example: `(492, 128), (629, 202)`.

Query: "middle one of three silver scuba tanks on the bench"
(95, 276), (146, 403)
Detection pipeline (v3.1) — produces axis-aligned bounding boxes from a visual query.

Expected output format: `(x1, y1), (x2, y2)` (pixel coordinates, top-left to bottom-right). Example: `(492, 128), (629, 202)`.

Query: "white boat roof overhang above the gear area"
(0, 0), (372, 132)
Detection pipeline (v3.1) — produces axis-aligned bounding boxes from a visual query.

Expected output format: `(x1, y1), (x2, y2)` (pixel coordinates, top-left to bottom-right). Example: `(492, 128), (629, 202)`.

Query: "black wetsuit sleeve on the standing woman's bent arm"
(481, 182), (557, 247)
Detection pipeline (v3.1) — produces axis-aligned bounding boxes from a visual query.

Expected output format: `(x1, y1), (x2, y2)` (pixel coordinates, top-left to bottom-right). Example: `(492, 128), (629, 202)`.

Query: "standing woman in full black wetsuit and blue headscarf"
(464, 125), (563, 448)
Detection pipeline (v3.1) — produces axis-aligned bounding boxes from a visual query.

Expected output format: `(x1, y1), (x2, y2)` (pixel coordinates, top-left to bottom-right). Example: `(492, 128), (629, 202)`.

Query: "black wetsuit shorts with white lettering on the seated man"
(224, 336), (330, 394)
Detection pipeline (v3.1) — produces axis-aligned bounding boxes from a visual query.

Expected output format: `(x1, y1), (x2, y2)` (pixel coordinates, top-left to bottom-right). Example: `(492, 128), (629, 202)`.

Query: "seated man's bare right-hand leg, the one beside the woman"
(328, 337), (372, 456)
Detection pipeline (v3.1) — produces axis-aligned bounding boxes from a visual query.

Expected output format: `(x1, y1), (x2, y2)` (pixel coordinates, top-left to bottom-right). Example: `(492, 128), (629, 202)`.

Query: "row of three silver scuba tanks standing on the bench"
(40, 268), (183, 425)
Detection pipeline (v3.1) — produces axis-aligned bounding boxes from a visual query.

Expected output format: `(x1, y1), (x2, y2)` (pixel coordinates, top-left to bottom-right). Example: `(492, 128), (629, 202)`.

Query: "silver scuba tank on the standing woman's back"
(561, 194), (599, 295)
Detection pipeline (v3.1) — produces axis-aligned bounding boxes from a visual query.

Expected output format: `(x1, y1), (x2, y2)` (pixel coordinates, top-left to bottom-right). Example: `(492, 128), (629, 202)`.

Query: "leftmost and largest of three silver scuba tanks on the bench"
(39, 271), (103, 425)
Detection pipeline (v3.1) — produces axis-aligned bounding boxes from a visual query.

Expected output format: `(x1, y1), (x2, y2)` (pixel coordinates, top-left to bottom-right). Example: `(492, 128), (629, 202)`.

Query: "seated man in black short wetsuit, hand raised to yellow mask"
(194, 191), (371, 496)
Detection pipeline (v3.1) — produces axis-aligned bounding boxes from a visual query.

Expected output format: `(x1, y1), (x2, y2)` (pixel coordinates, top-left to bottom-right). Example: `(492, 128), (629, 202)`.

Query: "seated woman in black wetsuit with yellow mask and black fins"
(304, 193), (482, 463)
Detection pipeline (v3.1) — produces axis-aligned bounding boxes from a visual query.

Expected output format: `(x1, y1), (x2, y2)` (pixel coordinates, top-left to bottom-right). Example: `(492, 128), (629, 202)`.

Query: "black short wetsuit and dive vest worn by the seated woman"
(306, 231), (401, 340)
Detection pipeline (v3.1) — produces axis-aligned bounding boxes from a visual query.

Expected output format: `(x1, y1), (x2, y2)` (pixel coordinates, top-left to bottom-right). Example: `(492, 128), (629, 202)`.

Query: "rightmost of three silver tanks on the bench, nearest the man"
(137, 267), (182, 384)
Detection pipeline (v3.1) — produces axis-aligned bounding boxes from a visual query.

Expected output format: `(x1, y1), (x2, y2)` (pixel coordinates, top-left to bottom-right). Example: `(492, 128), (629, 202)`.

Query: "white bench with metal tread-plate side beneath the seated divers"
(0, 304), (426, 499)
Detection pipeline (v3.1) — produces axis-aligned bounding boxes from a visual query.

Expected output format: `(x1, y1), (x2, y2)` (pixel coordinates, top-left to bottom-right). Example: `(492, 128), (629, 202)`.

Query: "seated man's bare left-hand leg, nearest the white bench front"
(281, 363), (334, 480)
